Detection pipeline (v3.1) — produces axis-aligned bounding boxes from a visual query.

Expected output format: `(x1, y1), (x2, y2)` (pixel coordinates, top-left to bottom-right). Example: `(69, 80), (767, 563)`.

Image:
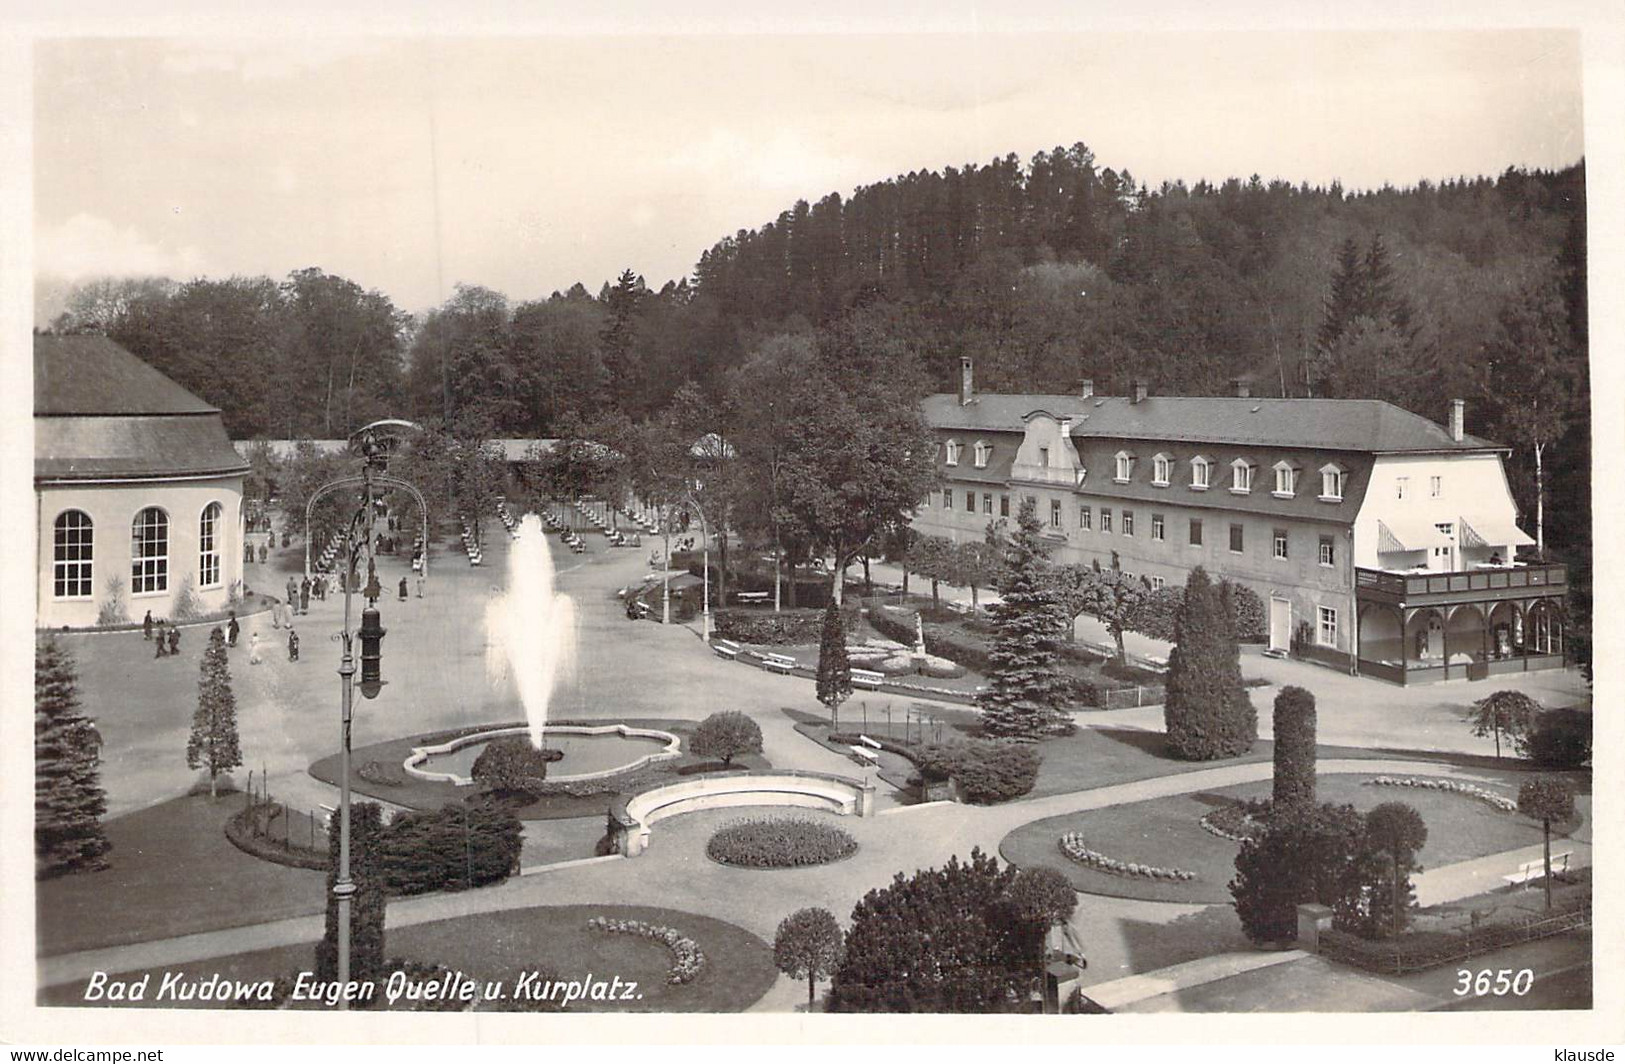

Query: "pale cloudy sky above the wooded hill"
(33, 31), (1583, 314)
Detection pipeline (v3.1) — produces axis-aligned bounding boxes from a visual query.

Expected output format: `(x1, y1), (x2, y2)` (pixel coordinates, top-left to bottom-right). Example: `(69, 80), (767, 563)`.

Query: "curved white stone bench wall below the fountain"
(609, 772), (874, 858)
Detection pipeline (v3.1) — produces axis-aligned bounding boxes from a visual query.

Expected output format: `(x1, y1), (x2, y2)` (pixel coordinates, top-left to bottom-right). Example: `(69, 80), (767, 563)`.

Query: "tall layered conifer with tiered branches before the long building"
(980, 497), (1073, 739)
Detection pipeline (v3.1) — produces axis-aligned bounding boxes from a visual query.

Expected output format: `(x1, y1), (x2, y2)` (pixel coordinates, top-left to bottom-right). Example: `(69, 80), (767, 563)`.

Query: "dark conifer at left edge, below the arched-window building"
(34, 637), (112, 879)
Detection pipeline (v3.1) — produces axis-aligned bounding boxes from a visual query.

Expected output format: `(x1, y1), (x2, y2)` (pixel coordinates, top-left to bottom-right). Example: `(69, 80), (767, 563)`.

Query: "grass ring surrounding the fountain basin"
(310, 720), (770, 820)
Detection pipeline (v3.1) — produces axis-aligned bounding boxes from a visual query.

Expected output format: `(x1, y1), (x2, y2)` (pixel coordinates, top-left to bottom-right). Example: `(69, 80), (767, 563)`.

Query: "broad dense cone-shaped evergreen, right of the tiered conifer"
(1164, 565), (1258, 760)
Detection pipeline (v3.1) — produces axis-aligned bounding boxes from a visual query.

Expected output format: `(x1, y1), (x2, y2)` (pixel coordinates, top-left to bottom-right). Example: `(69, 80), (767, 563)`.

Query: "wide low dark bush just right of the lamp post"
(379, 804), (523, 893)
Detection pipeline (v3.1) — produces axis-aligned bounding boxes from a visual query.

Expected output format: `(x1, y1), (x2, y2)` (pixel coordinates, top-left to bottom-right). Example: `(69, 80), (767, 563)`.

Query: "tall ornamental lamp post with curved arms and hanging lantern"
(307, 422), (429, 1009)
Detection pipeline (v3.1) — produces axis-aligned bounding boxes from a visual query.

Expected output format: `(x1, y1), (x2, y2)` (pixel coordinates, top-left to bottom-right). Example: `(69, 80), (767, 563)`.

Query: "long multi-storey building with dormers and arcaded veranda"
(913, 359), (1567, 684)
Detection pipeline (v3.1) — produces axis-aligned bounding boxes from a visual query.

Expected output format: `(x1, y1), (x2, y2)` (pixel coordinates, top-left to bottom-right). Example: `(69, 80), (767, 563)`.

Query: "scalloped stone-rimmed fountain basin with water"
(412, 724), (683, 786)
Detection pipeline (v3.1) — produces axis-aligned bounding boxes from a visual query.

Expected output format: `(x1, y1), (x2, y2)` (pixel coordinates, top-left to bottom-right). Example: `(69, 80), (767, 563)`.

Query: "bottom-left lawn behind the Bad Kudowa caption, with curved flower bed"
(41, 905), (778, 1012)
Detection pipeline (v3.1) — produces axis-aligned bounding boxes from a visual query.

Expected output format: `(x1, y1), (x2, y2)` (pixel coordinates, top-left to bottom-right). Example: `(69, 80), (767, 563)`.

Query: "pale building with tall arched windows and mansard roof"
(34, 336), (249, 629)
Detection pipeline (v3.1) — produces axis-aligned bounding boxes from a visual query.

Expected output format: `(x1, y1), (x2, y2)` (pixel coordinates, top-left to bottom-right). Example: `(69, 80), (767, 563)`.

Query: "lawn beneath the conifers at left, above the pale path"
(36, 794), (325, 957)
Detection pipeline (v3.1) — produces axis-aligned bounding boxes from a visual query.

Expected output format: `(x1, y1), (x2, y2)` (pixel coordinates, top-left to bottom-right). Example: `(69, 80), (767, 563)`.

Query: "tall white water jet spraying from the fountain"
(486, 513), (575, 749)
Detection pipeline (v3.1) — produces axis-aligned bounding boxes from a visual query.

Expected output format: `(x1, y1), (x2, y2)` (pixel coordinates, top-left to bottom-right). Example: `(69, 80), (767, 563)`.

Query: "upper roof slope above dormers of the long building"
(925, 393), (1503, 453)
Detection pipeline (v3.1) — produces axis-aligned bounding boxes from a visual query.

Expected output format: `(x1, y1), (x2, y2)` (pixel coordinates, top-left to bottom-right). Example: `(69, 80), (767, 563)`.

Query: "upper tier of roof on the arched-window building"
(34, 335), (219, 417)
